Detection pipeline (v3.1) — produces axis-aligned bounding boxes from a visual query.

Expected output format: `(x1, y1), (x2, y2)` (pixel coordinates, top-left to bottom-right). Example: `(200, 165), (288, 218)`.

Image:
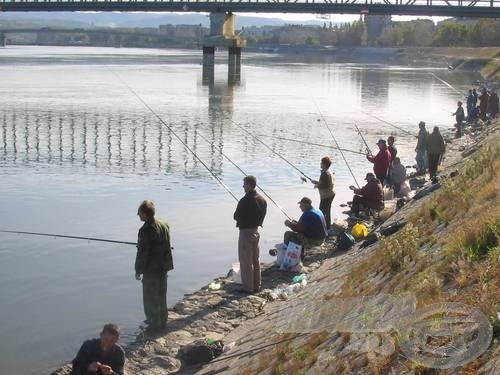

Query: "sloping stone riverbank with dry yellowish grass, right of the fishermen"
(54, 121), (500, 375)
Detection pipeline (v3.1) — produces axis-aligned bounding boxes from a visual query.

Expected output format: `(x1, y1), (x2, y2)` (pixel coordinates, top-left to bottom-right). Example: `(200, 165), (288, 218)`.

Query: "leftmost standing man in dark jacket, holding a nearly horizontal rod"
(135, 200), (174, 334)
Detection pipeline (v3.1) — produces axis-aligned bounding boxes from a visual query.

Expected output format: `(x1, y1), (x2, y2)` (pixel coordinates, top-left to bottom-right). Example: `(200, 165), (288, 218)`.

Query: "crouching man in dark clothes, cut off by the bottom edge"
(71, 323), (125, 375)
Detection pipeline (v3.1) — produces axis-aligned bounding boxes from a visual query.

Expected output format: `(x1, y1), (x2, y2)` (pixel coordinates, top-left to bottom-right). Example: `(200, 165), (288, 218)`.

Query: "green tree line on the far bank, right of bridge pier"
(241, 19), (500, 47)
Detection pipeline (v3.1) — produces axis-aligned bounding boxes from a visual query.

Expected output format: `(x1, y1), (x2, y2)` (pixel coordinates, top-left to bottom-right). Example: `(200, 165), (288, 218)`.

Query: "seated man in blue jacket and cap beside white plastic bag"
(283, 197), (328, 260)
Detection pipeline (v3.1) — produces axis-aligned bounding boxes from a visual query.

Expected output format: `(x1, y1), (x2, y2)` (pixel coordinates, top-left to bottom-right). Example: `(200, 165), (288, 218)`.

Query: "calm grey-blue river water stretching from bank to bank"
(0, 46), (476, 374)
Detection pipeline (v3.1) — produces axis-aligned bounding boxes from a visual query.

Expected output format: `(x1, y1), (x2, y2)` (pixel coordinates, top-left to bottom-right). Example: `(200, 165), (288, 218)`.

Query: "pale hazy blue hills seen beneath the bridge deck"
(0, 12), (325, 28)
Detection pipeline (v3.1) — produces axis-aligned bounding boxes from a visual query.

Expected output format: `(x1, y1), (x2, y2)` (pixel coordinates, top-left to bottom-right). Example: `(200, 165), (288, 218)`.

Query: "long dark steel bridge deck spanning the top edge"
(0, 0), (500, 18)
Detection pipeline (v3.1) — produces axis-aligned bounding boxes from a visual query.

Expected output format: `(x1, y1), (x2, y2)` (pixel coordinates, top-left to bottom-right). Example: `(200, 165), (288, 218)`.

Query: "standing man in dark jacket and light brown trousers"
(234, 176), (267, 293)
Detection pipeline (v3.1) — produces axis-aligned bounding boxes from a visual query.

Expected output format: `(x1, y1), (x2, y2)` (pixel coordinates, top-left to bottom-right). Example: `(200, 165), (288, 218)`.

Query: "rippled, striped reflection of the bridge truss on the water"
(0, 109), (230, 178)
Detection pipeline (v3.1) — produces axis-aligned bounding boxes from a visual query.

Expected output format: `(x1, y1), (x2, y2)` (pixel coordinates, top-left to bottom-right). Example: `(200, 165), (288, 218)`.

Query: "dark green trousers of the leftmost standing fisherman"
(142, 273), (168, 329)
